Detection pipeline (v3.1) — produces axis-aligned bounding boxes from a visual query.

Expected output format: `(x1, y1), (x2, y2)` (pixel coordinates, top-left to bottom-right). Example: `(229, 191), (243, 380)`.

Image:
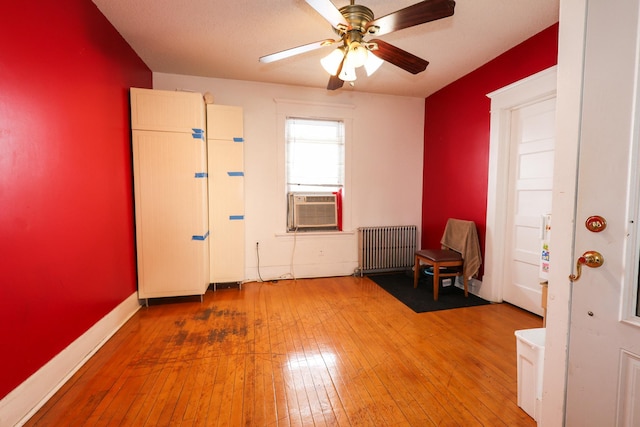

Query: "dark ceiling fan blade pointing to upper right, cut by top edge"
(366, 0), (456, 36)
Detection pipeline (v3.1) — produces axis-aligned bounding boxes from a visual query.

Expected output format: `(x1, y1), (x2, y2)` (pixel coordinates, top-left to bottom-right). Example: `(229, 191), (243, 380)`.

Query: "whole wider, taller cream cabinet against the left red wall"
(131, 88), (209, 299)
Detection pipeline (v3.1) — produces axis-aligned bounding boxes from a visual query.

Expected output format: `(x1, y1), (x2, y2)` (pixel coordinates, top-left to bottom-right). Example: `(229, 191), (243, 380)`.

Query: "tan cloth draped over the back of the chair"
(440, 218), (482, 278)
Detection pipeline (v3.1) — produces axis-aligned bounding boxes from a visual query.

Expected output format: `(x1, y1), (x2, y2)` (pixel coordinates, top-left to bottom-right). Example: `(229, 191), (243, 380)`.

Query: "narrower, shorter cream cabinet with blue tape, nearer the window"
(207, 104), (245, 284)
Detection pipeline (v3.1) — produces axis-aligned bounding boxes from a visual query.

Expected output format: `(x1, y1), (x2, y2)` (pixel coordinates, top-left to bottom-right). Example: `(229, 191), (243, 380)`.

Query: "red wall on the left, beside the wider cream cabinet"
(0, 0), (152, 398)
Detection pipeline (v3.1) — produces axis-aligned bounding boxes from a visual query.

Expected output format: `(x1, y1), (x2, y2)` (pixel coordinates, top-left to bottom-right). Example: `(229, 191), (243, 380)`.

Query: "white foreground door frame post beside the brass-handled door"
(539, 0), (589, 426)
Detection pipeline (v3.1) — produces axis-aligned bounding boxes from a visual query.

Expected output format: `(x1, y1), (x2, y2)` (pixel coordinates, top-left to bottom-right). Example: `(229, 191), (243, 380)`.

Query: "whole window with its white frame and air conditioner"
(274, 98), (355, 237)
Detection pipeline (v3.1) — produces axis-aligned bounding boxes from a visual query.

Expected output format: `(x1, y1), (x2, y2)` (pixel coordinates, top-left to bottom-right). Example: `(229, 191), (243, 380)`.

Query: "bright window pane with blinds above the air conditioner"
(285, 117), (345, 193)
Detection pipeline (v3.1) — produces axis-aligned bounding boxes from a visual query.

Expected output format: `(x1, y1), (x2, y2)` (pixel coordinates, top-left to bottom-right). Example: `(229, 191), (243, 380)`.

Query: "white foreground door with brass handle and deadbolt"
(564, 0), (640, 427)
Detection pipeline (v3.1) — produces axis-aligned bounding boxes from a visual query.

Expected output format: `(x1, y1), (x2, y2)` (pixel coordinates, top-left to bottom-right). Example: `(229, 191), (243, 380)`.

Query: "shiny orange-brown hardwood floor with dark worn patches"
(27, 277), (542, 427)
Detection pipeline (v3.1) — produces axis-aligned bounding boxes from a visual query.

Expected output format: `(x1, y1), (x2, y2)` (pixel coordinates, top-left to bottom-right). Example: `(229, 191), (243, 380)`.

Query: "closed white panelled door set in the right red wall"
(503, 97), (556, 315)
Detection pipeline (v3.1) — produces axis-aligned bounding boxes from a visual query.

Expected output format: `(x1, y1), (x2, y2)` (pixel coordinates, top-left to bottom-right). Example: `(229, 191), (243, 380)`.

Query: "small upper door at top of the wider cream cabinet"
(131, 88), (205, 133)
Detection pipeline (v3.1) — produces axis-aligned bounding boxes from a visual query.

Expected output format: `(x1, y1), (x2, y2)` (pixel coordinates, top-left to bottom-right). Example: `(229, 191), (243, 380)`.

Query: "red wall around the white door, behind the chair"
(422, 24), (558, 278)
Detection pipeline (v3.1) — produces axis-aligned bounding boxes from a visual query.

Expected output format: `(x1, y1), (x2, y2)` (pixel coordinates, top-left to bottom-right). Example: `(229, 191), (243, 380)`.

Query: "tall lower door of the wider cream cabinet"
(133, 131), (209, 298)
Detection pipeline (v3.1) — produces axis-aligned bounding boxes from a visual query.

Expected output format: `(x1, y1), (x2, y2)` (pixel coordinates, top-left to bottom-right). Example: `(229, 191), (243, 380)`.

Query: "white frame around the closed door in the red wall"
(478, 65), (557, 302)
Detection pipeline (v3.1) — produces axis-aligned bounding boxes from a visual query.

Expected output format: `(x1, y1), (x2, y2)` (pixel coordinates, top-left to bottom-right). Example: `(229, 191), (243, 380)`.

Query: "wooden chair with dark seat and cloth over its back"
(413, 218), (482, 301)
